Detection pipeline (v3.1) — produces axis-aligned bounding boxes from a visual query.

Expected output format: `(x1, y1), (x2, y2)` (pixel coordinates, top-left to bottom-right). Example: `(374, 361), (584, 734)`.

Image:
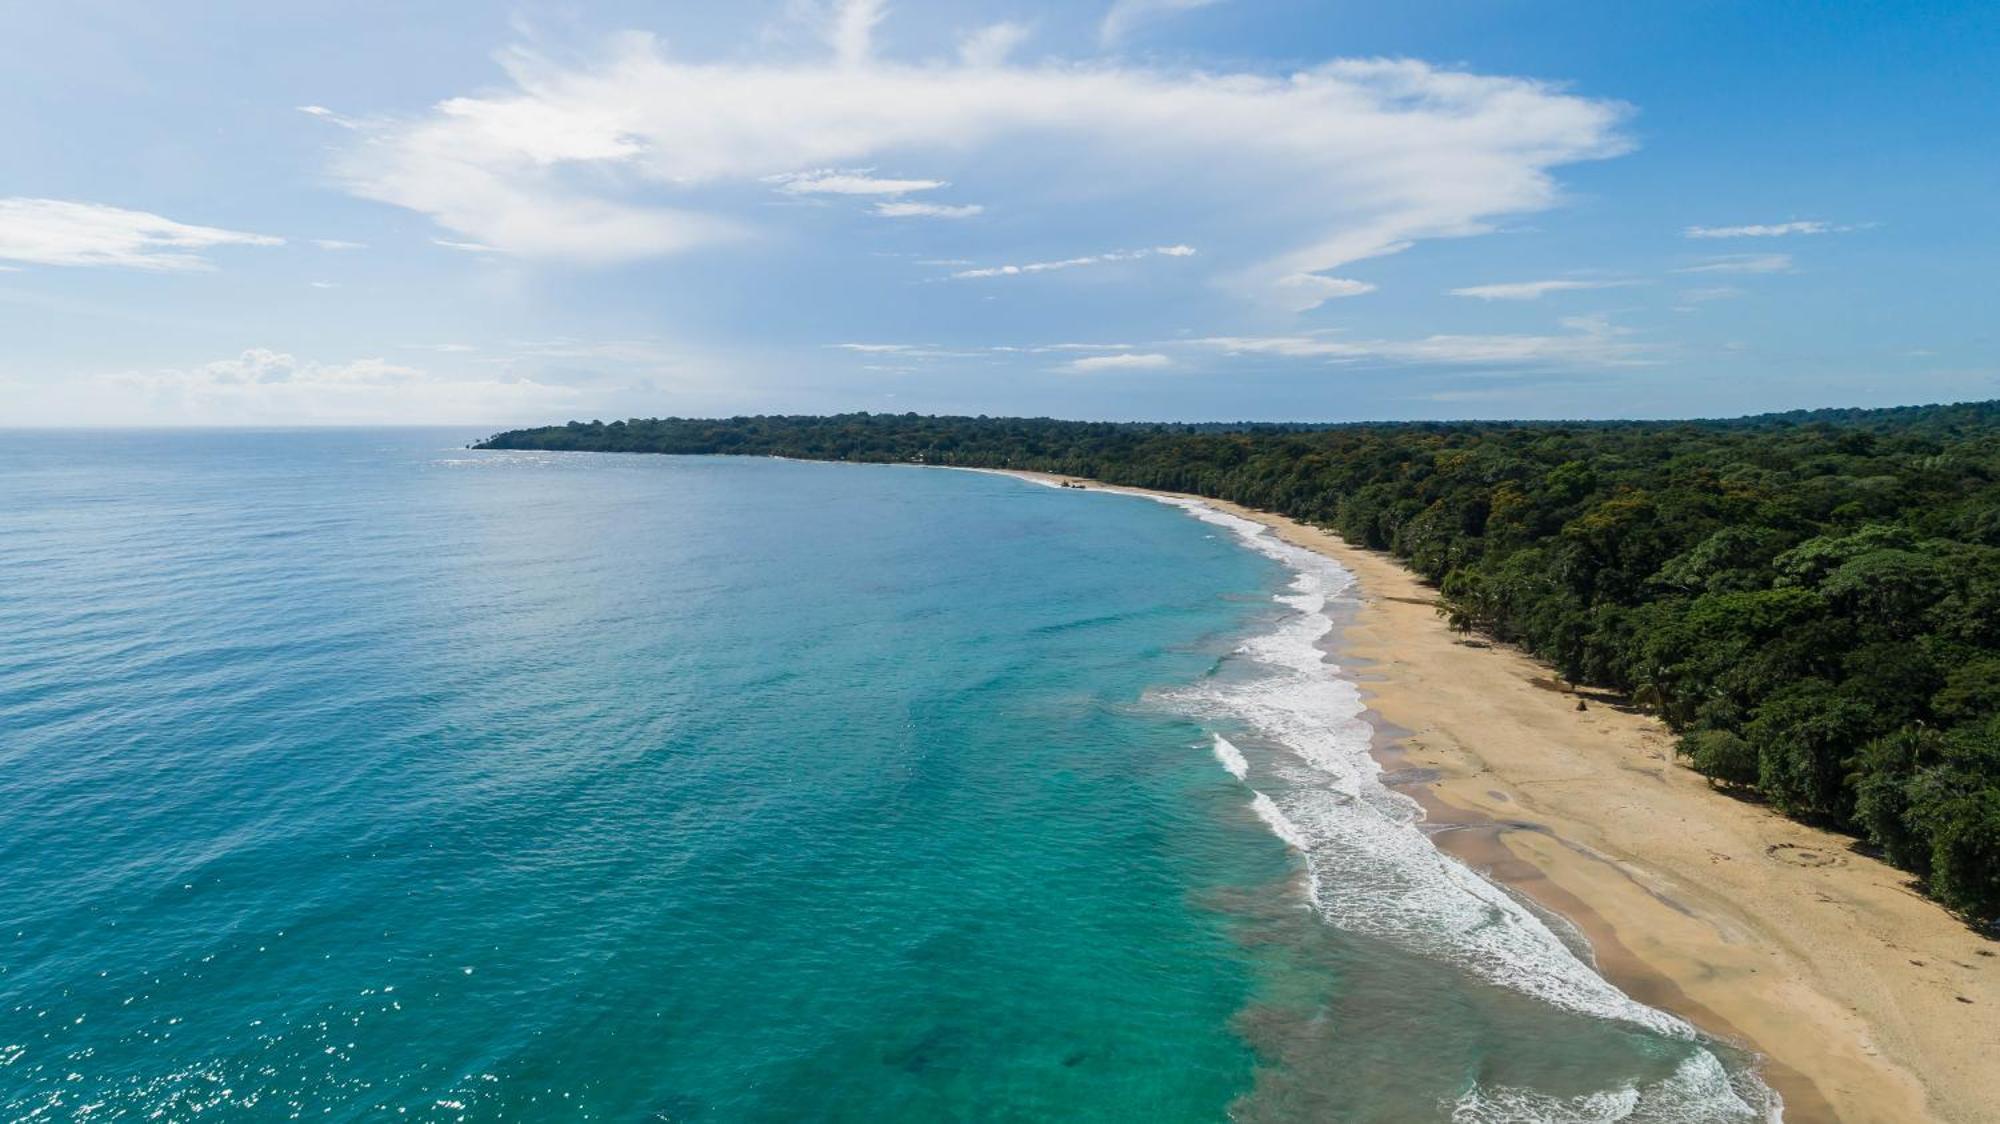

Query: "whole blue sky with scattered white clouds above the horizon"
(0, 0), (2000, 428)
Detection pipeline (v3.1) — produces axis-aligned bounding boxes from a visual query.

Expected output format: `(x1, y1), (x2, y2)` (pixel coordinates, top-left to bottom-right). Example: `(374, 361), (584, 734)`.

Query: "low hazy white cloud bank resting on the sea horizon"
(11, 348), (584, 426)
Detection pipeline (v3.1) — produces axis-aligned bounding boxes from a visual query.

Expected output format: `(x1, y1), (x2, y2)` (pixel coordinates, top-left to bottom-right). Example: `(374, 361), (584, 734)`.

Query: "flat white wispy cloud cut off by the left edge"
(0, 196), (284, 272)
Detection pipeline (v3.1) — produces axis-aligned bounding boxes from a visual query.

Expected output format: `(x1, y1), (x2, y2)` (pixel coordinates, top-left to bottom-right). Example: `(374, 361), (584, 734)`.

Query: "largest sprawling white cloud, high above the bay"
(312, 25), (1628, 308)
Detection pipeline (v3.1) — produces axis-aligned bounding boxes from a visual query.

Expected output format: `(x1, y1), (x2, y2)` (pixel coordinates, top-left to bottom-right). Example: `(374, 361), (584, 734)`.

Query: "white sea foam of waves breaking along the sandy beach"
(1152, 496), (1780, 1122)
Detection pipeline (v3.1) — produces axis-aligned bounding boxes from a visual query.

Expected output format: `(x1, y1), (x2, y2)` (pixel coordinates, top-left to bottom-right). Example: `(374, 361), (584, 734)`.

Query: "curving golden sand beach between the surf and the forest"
(1012, 472), (2000, 1122)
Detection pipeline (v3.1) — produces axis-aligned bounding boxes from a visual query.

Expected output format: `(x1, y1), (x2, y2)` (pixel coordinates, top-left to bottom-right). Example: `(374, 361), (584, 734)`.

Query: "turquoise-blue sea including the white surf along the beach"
(0, 430), (1758, 1120)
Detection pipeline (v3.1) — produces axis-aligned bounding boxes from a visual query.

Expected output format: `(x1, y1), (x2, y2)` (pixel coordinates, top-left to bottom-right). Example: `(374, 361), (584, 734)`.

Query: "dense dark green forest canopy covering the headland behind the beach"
(484, 402), (2000, 926)
